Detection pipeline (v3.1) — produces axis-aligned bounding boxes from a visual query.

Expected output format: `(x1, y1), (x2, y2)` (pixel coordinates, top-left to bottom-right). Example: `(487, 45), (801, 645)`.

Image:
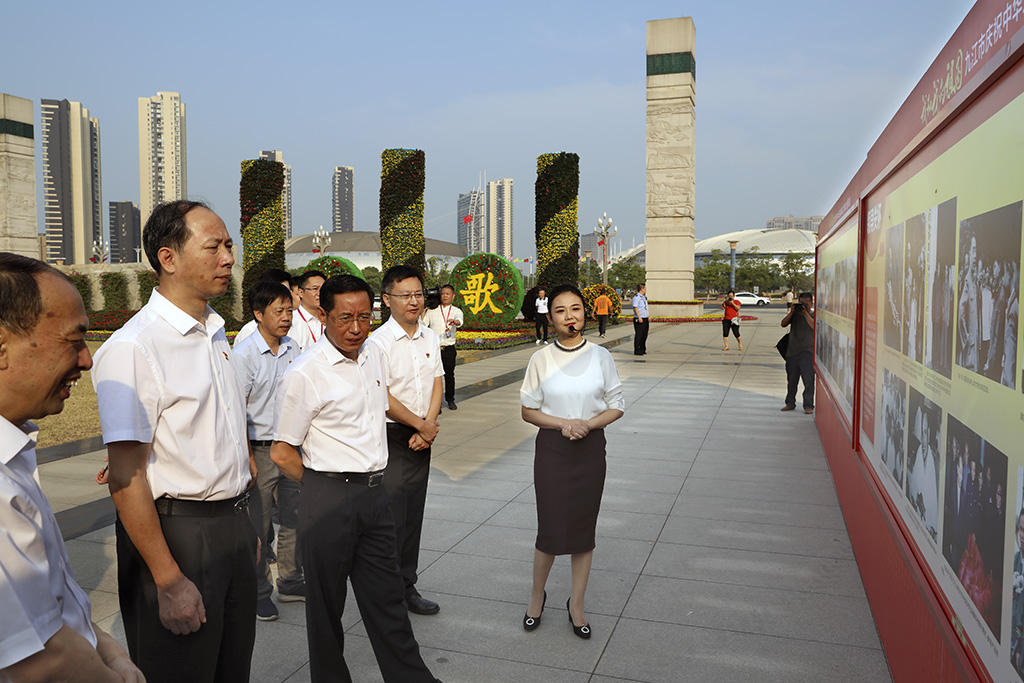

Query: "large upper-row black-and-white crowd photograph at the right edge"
(956, 202), (1022, 389)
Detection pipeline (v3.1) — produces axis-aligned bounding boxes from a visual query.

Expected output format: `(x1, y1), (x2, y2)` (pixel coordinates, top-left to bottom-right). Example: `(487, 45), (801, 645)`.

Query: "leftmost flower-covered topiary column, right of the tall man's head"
(239, 159), (285, 321)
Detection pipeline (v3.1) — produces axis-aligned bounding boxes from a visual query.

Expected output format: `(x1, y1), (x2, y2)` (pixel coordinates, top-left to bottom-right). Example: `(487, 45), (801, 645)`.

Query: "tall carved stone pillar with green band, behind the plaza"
(646, 16), (702, 317)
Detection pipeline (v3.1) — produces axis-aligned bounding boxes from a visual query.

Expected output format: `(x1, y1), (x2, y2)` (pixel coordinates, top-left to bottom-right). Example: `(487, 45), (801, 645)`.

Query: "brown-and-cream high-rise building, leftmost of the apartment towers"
(40, 99), (103, 264)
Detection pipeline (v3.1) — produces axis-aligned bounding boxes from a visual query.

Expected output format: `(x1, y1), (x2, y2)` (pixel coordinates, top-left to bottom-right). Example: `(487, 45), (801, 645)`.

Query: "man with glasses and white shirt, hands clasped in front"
(370, 265), (444, 614)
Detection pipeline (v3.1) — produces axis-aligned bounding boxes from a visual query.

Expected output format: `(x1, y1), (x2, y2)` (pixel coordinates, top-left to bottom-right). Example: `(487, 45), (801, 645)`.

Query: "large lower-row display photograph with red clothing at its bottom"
(942, 415), (1008, 640)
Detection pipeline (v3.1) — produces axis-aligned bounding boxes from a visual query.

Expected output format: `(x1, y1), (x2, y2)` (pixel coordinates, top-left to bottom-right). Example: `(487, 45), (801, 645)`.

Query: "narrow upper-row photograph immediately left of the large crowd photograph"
(925, 198), (956, 379)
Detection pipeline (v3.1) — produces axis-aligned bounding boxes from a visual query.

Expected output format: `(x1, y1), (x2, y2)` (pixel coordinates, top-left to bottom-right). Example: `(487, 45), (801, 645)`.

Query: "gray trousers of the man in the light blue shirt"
(249, 445), (304, 599)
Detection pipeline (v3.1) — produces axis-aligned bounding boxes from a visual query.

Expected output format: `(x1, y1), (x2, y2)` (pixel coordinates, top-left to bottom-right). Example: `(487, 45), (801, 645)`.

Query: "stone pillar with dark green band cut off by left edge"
(0, 93), (39, 258)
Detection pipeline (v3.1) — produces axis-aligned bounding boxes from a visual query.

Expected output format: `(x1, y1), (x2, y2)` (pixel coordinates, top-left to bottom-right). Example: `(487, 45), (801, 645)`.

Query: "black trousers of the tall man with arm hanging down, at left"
(115, 511), (256, 683)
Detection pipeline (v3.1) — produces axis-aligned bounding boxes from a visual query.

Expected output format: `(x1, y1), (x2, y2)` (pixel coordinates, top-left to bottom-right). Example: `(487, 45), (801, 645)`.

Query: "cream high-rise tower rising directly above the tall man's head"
(138, 92), (188, 225)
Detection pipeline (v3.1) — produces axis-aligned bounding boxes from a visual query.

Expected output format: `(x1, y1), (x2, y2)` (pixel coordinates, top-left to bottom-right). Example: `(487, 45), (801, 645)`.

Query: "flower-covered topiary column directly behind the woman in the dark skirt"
(536, 152), (580, 290)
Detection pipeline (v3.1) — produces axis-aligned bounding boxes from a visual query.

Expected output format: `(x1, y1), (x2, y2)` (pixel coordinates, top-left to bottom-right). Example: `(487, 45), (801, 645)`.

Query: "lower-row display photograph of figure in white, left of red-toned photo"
(906, 386), (942, 541)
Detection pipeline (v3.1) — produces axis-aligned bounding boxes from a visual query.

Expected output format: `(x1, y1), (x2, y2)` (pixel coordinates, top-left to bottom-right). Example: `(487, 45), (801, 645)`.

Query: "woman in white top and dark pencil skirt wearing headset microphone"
(519, 285), (626, 638)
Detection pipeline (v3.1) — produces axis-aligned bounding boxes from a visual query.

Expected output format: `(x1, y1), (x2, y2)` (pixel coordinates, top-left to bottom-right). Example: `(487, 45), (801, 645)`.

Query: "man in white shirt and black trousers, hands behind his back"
(270, 274), (435, 683)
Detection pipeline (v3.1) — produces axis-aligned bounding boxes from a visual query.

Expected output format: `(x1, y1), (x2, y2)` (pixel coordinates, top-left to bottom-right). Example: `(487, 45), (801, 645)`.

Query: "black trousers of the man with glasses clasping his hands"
(384, 423), (430, 593)
